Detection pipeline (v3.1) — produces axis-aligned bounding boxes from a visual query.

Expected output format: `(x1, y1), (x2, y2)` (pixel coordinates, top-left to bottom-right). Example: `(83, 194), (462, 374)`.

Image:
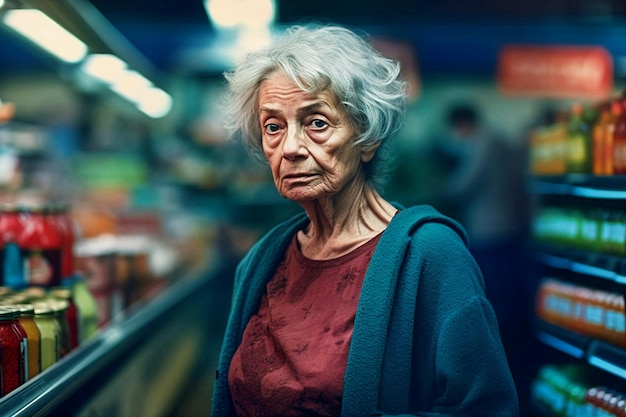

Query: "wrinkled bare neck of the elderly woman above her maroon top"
(297, 184), (397, 259)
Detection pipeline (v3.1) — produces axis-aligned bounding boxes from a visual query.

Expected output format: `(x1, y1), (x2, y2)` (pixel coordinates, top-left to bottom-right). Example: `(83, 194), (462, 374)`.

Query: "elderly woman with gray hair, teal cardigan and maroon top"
(212, 26), (518, 417)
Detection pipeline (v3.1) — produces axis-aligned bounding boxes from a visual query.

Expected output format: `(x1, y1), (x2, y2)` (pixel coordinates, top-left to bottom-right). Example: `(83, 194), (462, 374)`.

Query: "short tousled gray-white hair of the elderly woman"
(222, 24), (406, 188)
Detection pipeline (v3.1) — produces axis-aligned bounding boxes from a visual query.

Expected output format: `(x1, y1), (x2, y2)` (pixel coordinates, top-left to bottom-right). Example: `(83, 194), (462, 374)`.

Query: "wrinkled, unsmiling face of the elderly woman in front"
(259, 73), (374, 202)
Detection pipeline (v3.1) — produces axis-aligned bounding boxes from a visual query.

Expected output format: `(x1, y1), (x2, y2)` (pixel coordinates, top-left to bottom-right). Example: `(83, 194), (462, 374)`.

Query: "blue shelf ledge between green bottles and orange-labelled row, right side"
(536, 246), (626, 285)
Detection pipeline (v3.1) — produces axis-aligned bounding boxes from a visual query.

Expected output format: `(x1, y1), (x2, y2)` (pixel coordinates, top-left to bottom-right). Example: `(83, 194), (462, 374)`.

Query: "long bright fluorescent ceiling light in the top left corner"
(3, 9), (87, 63)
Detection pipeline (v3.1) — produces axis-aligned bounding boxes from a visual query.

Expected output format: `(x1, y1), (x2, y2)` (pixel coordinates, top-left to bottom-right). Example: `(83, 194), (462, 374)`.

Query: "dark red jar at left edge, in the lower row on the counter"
(0, 306), (28, 396)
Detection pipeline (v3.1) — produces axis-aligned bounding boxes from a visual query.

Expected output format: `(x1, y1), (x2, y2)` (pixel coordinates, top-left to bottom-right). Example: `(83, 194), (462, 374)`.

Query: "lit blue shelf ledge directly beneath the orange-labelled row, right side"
(535, 318), (626, 379)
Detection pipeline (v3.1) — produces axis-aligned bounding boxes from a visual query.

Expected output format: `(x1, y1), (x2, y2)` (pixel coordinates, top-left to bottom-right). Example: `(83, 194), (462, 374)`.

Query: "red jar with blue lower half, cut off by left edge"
(0, 203), (26, 289)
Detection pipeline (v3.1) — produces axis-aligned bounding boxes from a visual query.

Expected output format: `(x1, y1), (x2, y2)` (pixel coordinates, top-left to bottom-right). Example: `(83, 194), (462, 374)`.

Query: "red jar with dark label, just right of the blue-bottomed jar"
(19, 205), (62, 288)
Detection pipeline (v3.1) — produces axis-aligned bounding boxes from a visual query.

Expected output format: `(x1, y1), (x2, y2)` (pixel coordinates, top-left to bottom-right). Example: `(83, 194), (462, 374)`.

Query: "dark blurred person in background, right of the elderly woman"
(439, 101), (532, 412)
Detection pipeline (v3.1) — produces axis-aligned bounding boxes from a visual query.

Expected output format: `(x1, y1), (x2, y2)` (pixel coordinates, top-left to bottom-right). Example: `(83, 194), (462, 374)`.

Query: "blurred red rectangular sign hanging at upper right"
(498, 46), (613, 98)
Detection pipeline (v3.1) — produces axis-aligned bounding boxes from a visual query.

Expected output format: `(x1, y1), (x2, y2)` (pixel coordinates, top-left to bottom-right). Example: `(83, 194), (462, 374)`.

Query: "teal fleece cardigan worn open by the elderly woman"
(212, 205), (518, 417)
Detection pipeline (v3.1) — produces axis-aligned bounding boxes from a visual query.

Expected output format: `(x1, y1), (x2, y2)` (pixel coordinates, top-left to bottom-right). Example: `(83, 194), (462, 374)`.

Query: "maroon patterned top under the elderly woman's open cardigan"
(228, 234), (381, 417)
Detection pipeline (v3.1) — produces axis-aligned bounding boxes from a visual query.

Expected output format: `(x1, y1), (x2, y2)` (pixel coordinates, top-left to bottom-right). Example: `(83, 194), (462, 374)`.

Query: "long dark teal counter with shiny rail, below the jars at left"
(0, 264), (218, 417)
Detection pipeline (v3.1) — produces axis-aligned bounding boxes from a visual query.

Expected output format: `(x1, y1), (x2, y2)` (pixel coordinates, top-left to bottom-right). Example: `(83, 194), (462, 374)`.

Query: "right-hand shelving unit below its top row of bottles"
(530, 173), (626, 416)
